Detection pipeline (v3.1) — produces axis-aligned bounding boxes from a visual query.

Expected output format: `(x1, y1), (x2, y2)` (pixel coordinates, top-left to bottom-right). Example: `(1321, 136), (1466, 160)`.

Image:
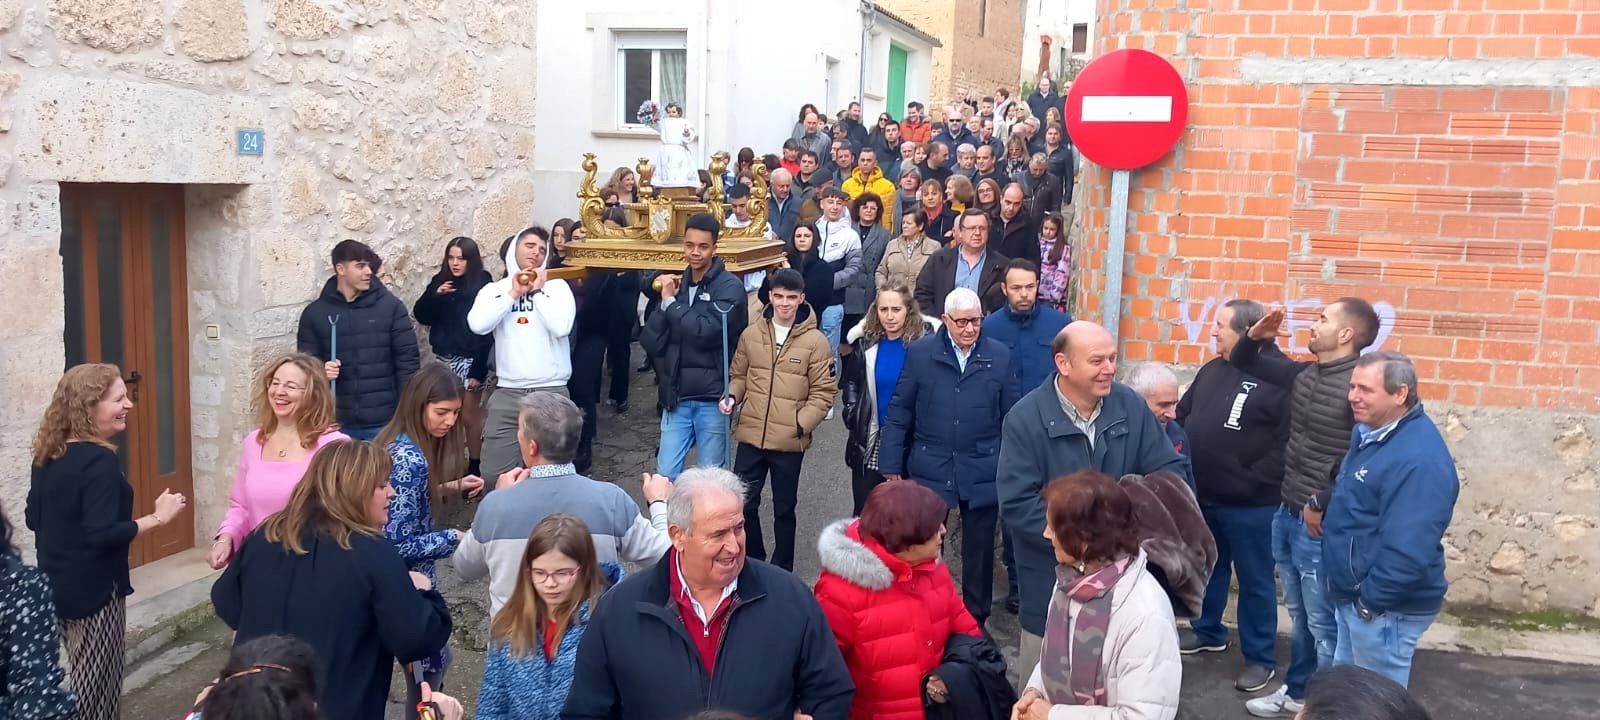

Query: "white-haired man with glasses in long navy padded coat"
(878, 288), (1017, 626)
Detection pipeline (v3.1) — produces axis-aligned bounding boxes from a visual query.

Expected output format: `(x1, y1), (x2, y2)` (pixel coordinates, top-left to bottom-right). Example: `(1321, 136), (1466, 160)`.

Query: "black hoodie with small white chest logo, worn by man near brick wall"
(1178, 338), (1290, 507)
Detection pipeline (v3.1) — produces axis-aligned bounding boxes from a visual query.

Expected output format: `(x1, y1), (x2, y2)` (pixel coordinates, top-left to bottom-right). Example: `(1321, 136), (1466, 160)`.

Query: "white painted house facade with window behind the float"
(534, 0), (933, 214)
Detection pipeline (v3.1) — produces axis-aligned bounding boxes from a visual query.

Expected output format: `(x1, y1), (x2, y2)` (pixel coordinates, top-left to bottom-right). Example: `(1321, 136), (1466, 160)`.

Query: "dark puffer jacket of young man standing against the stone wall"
(294, 277), (421, 427)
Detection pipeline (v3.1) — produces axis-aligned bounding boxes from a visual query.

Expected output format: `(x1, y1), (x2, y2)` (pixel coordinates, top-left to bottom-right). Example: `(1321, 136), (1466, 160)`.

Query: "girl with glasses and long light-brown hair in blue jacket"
(477, 514), (622, 720)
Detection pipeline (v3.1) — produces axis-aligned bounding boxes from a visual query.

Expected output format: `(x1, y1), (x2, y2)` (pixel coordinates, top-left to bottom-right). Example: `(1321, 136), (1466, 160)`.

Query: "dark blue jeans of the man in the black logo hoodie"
(1189, 506), (1278, 669)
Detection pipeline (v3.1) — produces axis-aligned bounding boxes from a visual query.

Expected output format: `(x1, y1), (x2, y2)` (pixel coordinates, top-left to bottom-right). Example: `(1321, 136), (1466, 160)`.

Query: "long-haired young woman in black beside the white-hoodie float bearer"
(411, 237), (494, 475)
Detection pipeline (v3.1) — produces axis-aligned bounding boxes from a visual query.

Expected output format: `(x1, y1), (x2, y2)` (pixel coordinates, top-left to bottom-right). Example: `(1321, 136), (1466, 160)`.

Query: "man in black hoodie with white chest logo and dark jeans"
(1178, 299), (1290, 693)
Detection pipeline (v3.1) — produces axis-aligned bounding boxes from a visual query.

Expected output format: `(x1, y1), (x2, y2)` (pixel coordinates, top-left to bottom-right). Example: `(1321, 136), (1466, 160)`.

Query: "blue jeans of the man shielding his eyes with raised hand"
(1272, 507), (1339, 699)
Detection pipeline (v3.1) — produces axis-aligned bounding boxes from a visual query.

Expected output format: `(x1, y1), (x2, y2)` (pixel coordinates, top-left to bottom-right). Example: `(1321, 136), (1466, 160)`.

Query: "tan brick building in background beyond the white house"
(878, 0), (1022, 109)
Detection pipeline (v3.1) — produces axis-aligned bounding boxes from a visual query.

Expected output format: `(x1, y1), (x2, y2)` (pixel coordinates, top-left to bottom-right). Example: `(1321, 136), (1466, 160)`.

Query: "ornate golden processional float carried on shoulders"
(550, 152), (784, 278)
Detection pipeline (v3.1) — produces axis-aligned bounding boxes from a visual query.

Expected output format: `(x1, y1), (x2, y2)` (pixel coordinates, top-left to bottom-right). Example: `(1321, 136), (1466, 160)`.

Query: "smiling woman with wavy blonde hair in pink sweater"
(211, 354), (347, 568)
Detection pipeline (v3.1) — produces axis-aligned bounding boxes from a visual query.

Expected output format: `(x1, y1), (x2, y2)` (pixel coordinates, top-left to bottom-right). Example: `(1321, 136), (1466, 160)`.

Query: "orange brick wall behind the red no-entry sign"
(1078, 0), (1600, 411)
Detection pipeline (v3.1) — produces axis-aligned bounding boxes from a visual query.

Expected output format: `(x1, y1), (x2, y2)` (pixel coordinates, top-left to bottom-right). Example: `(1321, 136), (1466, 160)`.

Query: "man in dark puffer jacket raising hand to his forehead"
(1229, 298), (1379, 717)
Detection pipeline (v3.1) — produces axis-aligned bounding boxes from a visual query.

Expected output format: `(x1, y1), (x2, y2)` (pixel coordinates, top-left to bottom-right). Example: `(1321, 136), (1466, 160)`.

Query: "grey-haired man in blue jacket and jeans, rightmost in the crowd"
(1312, 350), (1461, 685)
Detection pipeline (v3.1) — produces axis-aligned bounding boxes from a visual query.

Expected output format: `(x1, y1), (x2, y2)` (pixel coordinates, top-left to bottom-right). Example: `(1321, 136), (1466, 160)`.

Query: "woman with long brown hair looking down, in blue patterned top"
(373, 360), (483, 717)
